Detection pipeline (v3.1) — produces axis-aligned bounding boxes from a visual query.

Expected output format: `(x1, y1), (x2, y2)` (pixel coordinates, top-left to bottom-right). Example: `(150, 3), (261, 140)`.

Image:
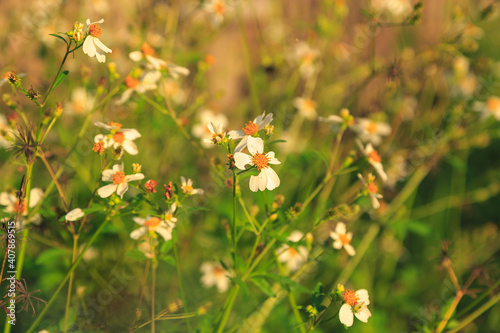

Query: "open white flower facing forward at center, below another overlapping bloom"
(234, 136), (281, 192)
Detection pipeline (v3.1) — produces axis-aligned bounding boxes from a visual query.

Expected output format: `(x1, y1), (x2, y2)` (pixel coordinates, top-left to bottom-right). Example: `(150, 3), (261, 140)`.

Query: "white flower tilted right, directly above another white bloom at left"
(94, 121), (141, 155)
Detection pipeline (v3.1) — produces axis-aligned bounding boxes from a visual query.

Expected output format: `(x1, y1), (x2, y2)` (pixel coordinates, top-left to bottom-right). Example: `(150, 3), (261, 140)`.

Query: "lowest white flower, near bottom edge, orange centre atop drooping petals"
(339, 289), (372, 327)
